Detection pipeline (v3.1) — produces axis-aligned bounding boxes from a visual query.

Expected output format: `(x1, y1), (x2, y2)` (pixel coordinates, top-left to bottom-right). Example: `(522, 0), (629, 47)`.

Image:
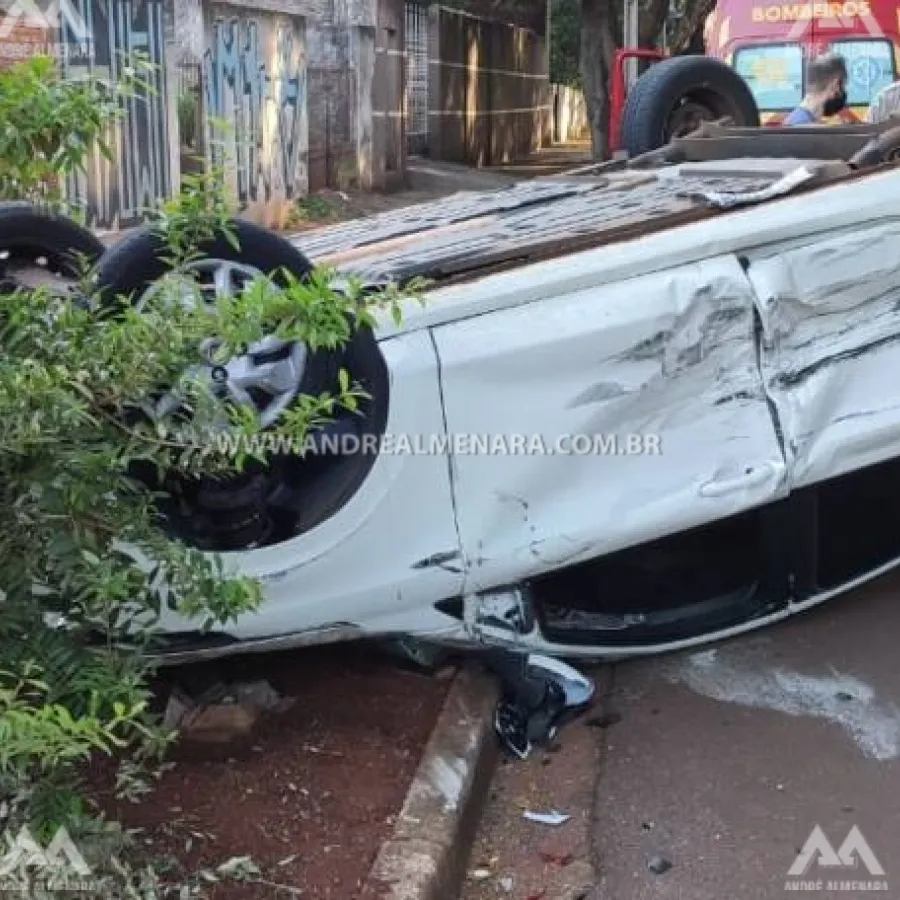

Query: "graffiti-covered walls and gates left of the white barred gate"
(0, 0), (405, 229)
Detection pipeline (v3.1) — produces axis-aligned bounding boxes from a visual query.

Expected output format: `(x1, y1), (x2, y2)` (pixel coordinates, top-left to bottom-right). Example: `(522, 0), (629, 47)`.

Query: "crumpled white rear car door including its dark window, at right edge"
(747, 220), (900, 603)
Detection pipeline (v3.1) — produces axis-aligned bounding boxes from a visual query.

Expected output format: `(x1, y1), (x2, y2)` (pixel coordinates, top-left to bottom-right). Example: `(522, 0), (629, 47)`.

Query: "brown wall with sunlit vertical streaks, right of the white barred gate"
(428, 6), (551, 166)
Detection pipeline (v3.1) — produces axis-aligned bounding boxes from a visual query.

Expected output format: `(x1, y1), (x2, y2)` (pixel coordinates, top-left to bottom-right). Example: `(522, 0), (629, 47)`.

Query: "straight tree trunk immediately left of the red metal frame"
(580, 0), (616, 160)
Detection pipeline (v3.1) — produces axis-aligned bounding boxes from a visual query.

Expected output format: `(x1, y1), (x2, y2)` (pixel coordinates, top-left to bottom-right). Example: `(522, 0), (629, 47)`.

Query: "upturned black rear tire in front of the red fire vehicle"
(621, 56), (759, 156)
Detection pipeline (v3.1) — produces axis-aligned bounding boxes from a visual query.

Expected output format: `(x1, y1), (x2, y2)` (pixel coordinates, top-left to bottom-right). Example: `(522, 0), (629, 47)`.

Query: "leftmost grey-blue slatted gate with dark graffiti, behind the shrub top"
(62, 0), (172, 228)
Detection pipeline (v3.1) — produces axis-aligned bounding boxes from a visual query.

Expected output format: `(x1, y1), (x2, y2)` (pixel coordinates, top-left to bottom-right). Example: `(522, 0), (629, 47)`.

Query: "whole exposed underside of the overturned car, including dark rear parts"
(295, 119), (900, 284)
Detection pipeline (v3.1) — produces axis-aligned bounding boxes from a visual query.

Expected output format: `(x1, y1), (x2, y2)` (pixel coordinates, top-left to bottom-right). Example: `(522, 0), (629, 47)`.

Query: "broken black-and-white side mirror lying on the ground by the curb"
(484, 650), (595, 759)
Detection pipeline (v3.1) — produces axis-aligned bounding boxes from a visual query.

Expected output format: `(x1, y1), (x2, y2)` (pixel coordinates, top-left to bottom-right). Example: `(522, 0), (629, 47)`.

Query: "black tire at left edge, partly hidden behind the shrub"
(0, 201), (106, 278)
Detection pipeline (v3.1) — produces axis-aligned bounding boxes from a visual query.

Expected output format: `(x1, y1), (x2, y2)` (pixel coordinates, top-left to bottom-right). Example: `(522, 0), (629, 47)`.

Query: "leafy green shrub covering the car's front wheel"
(0, 49), (412, 884)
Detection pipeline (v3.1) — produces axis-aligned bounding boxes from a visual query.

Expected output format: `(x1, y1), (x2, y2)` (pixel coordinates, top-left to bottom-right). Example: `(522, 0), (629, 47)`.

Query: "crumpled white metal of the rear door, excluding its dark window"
(748, 219), (900, 487)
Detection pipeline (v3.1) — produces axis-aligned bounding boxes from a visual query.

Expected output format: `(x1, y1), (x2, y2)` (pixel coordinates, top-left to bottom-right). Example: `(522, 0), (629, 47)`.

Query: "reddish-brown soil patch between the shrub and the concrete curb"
(86, 643), (452, 900)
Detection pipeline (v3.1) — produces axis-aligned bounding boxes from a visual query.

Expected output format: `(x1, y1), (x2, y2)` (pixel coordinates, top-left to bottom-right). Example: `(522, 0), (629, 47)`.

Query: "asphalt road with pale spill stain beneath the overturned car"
(594, 575), (900, 900)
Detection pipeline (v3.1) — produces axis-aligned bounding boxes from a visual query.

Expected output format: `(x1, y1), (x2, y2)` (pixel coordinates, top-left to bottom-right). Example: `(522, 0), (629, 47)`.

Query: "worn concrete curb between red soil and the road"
(363, 668), (498, 900)
